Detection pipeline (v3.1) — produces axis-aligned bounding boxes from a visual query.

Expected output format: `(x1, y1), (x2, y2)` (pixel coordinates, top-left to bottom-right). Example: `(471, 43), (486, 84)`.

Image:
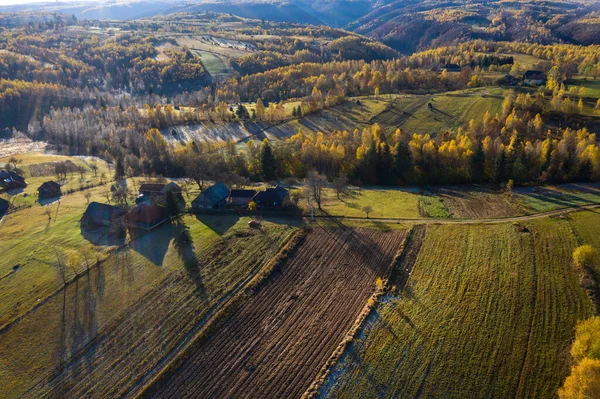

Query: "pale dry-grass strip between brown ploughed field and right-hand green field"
(302, 226), (413, 399)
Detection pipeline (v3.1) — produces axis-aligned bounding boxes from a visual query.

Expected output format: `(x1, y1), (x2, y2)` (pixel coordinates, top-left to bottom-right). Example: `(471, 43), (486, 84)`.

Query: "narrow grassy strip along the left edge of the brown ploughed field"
(132, 229), (308, 398)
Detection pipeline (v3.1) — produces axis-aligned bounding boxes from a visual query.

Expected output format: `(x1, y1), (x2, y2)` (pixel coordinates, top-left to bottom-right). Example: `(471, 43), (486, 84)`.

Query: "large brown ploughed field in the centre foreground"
(148, 228), (404, 398)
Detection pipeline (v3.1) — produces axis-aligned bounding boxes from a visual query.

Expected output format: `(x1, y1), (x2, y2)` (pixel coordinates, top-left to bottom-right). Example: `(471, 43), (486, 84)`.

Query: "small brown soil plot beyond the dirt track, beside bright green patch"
(436, 187), (522, 218)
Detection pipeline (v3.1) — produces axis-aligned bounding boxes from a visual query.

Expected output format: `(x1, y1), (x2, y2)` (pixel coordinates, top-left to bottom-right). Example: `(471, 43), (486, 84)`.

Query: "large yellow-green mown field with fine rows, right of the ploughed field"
(321, 219), (592, 398)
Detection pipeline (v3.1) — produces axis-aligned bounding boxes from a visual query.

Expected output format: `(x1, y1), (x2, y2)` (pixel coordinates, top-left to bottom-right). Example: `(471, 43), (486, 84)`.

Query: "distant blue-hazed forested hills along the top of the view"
(0, 0), (600, 54)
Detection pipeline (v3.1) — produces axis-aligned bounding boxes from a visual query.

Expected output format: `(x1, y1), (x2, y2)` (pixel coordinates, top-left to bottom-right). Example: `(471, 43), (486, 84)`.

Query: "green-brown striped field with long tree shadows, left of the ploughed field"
(0, 223), (296, 398)
